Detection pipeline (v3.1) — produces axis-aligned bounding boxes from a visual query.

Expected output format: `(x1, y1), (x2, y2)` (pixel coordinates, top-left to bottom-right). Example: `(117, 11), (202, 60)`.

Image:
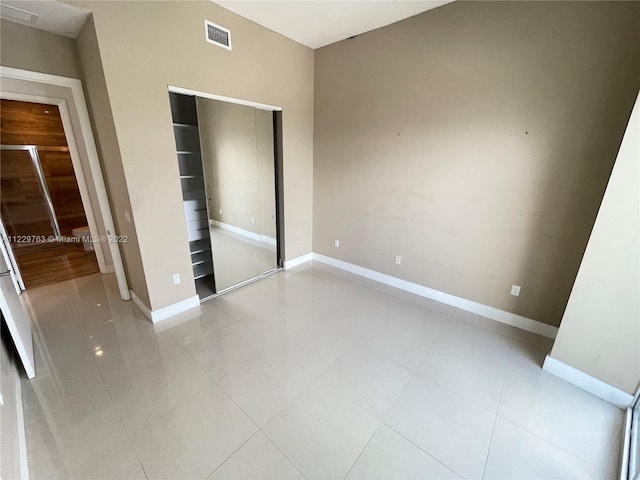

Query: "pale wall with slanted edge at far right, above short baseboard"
(551, 94), (640, 395)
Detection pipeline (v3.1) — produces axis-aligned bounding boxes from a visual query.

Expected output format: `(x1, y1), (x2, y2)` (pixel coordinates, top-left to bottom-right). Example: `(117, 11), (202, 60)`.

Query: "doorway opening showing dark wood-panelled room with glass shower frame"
(0, 99), (100, 288)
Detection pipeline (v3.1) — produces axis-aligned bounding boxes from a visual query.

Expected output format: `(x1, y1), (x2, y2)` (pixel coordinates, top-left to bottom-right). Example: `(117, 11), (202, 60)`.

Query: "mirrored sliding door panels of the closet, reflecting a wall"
(196, 97), (277, 292)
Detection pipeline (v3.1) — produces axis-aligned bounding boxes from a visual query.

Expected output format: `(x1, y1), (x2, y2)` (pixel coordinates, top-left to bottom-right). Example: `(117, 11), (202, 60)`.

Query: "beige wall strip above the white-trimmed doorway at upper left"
(0, 20), (82, 78)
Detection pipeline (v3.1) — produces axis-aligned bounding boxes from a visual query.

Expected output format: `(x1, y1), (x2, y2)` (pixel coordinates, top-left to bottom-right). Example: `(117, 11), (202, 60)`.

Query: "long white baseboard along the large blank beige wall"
(312, 253), (558, 338)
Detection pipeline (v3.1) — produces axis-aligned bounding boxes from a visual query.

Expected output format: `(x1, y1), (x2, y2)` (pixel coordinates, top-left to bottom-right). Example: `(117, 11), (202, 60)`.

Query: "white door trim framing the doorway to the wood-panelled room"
(0, 66), (131, 300)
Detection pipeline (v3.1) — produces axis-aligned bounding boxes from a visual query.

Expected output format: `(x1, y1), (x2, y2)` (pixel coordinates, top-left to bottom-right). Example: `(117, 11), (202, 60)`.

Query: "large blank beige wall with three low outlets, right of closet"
(313, 2), (640, 325)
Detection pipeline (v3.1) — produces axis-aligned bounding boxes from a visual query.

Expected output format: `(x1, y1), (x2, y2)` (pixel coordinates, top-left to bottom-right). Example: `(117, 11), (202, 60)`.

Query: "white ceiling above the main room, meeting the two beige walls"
(212, 0), (453, 48)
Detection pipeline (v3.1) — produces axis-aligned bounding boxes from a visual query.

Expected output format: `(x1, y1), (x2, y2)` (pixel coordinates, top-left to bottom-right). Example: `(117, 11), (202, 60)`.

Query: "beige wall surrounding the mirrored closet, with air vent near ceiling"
(70, 1), (313, 310)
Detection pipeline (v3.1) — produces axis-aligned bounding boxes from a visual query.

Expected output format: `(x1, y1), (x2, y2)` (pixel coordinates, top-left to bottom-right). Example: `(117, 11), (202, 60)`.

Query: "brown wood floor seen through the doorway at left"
(13, 243), (100, 289)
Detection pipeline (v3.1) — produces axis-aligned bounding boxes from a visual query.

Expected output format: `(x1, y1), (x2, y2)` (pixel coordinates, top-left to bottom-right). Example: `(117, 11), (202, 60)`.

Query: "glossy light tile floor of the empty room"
(18, 264), (622, 480)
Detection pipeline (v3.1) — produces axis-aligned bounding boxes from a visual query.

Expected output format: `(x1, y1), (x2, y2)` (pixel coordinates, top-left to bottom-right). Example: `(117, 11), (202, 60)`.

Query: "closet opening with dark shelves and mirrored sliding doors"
(170, 93), (279, 299)
